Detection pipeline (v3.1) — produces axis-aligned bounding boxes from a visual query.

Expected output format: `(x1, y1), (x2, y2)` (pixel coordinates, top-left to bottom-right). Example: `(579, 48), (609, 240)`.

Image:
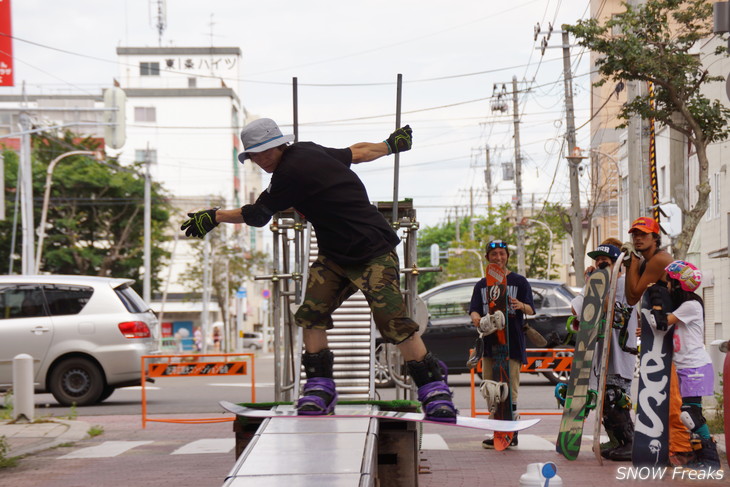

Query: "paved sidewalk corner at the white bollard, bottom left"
(0, 418), (89, 458)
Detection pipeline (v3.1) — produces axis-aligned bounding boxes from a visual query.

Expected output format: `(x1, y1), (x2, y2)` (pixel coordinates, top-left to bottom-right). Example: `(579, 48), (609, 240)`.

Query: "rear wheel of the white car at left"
(49, 358), (104, 406)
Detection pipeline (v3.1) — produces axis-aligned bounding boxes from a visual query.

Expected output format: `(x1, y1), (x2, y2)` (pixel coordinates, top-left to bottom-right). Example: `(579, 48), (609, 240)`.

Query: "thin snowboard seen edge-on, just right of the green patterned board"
(593, 252), (624, 465)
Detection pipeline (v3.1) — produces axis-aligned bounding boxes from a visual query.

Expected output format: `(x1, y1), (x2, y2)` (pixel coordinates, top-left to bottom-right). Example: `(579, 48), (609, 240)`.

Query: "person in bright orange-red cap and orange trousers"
(621, 216), (694, 466)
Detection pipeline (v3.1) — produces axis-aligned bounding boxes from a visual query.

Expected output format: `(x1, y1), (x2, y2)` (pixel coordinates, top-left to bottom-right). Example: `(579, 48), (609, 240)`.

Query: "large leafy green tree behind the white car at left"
(0, 132), (170, 291)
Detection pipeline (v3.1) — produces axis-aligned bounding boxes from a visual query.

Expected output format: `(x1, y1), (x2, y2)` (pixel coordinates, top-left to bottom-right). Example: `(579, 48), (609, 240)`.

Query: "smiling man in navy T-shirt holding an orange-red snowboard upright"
(469, 240), (544, 449)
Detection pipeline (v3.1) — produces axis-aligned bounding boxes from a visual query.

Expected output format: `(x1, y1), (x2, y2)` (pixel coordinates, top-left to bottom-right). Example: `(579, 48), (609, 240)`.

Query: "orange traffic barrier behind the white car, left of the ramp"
(141, 353), (256, 428)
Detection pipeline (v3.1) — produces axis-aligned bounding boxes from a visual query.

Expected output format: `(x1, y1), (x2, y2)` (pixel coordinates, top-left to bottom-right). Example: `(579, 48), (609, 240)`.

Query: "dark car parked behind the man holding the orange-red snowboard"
(376, 278), (576, 387)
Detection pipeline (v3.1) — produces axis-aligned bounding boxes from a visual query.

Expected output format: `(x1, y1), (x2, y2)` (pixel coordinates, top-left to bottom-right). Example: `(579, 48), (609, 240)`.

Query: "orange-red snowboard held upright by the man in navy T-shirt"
(486, 264), (514, 451)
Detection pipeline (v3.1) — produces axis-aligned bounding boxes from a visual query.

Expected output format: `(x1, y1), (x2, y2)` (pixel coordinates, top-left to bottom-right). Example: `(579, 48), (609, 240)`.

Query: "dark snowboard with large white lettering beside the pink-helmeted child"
(631, 284), (674, 467)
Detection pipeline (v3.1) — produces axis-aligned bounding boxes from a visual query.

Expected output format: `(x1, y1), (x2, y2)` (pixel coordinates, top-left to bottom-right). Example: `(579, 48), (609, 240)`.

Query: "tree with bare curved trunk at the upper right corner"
(563, 0), (730, 259)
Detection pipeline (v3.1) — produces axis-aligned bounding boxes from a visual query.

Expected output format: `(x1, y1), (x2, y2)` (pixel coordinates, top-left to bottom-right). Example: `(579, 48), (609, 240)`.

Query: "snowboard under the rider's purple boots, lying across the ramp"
(213, 401), (540, 431)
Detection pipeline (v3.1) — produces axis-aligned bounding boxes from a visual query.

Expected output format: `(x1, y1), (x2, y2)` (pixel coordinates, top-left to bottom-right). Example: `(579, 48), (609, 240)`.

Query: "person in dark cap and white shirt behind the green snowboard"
(571, 239), (637, 462)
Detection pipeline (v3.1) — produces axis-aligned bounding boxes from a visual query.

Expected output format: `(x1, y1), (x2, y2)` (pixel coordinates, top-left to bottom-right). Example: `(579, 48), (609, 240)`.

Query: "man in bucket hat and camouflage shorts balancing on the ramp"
(181, 118), (457, 423)
